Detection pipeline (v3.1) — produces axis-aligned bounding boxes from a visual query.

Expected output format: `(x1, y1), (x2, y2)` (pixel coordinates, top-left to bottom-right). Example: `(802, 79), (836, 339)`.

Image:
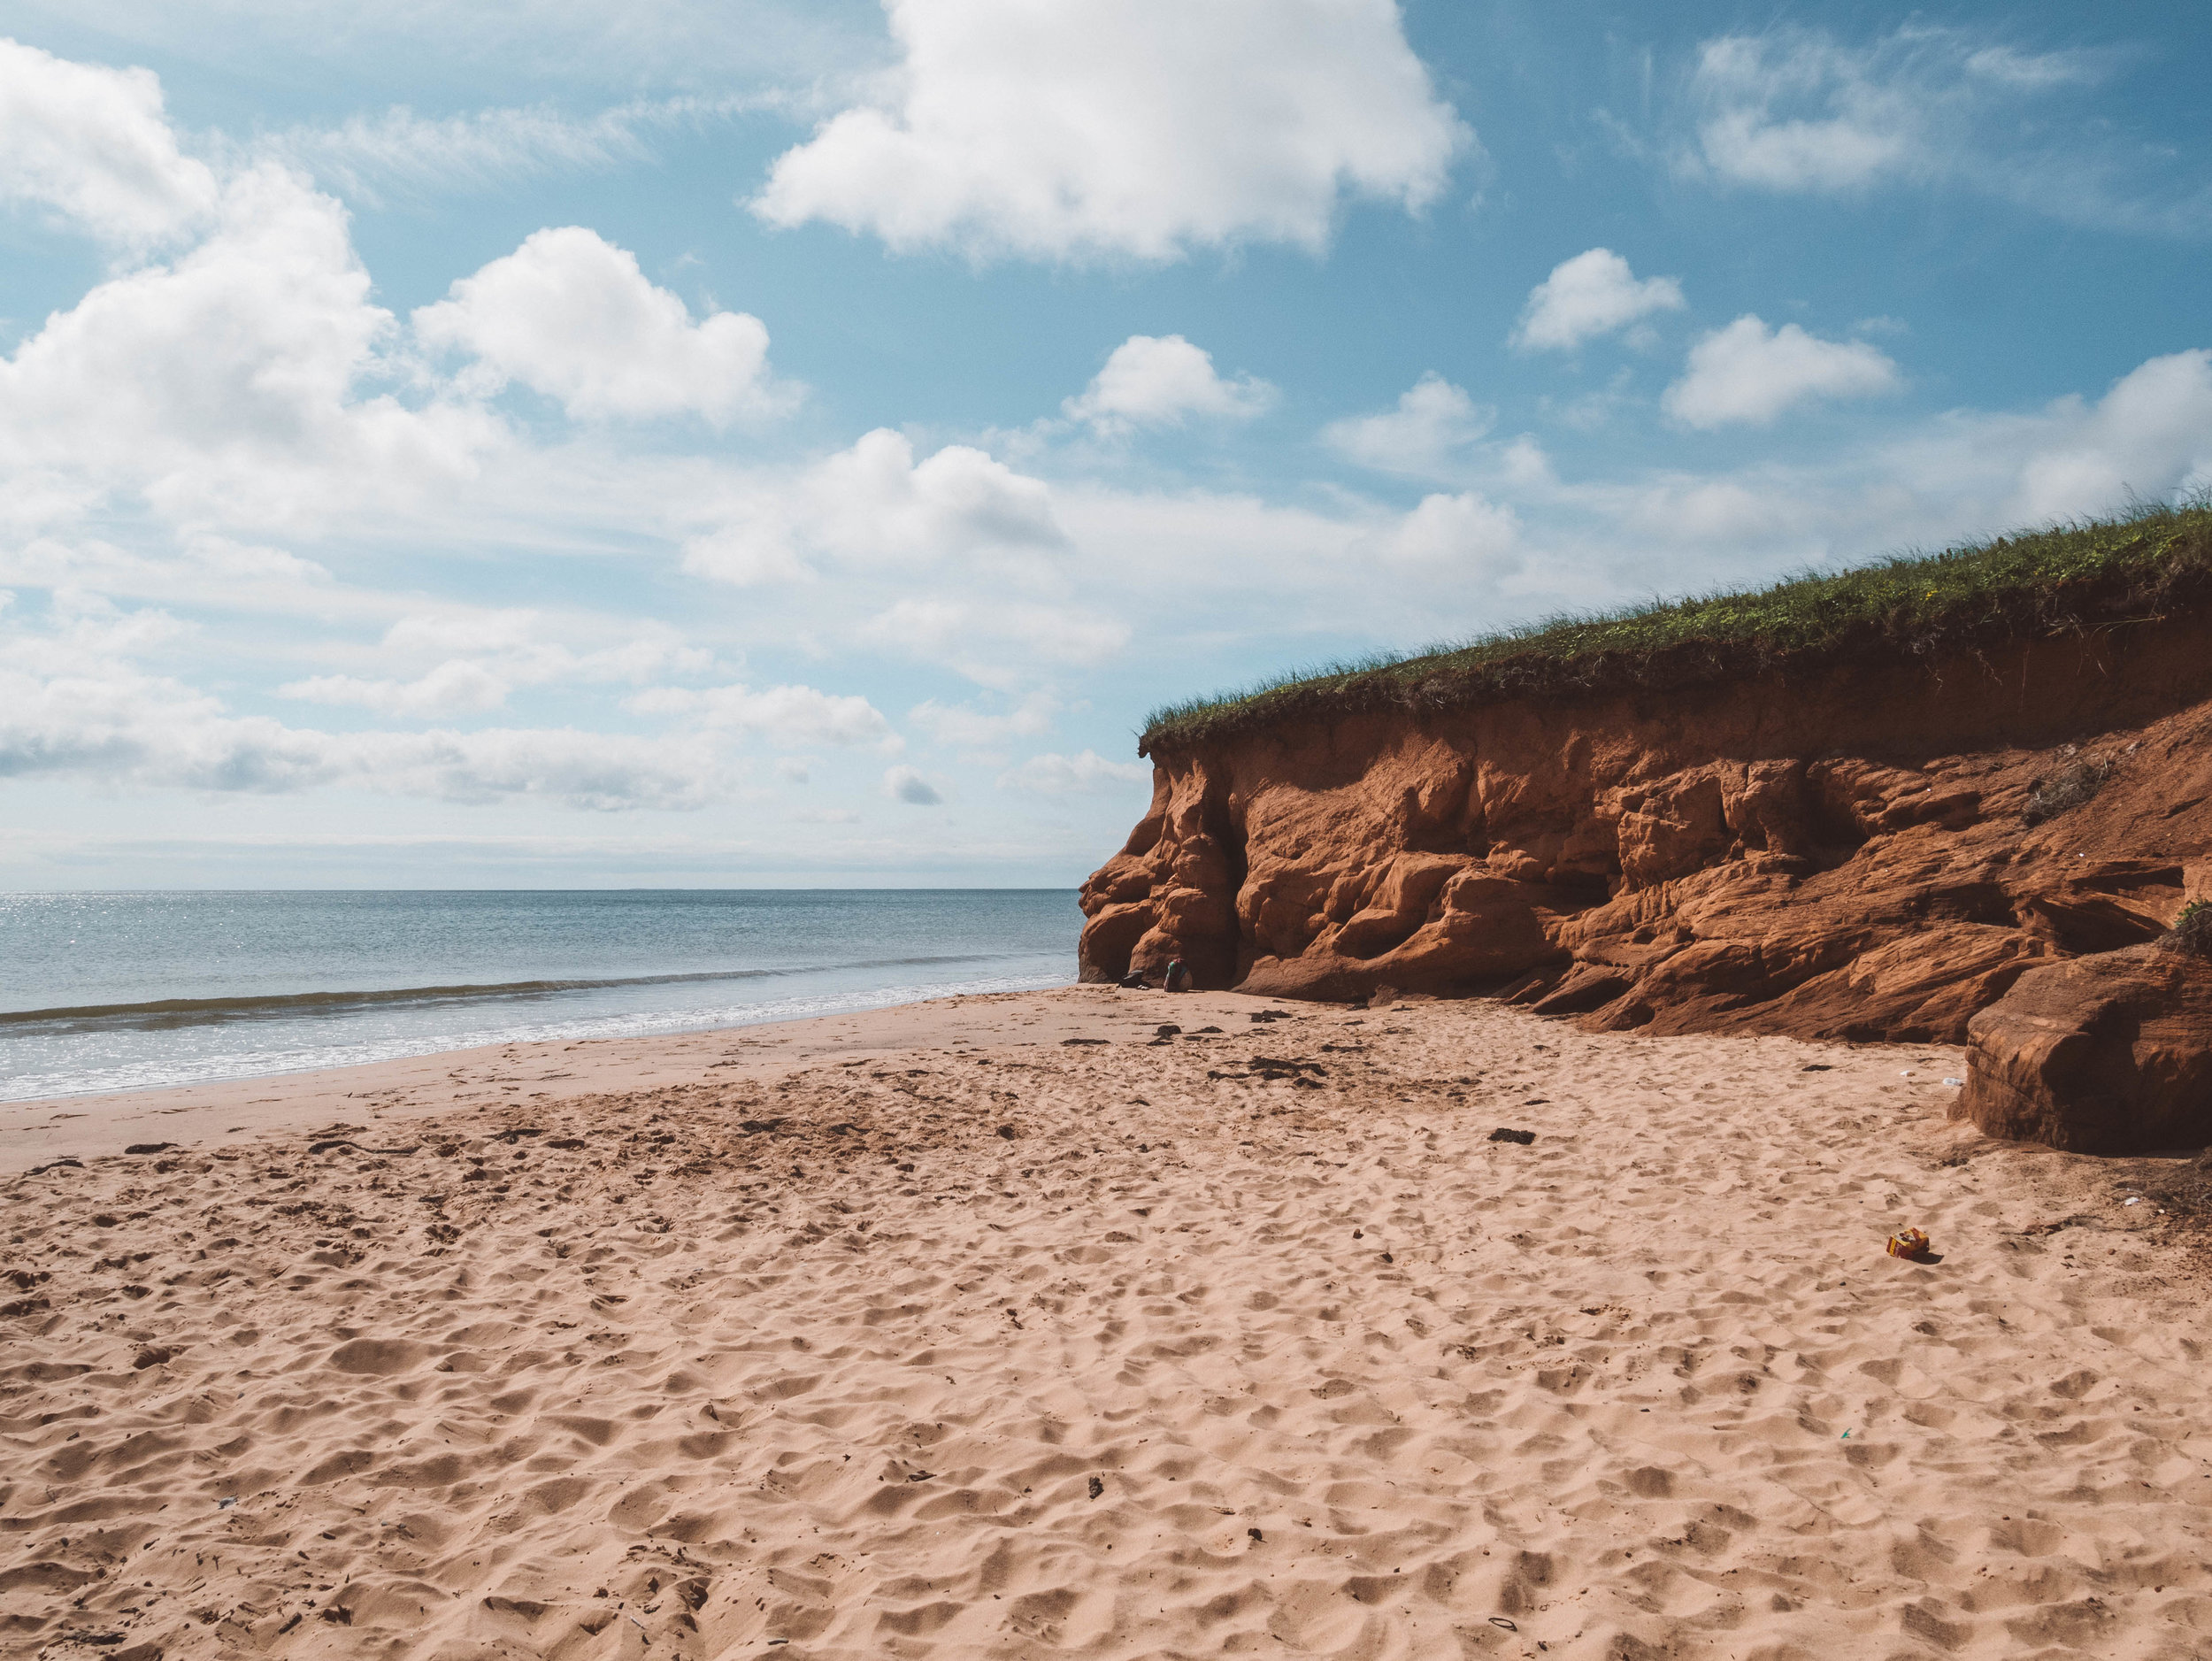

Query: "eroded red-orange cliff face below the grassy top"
(1082, 619), (2212, 1042)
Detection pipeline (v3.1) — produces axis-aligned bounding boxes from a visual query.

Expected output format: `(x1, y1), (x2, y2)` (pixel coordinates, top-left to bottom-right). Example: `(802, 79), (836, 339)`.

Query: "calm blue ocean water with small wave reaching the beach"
(0, 889), (1082, 1102)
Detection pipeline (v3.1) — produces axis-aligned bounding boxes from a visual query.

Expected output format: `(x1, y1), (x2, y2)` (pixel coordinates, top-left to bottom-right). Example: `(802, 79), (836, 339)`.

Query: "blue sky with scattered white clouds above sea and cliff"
(0, 0), (2212, 887)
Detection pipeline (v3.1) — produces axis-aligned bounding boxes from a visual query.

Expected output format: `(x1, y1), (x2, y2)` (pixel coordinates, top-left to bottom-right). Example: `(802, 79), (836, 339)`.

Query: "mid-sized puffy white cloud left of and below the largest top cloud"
(414, 226), (779, 425)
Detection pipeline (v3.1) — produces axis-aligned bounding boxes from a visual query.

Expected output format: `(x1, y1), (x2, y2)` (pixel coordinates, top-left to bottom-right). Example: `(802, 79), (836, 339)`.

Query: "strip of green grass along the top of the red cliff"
(1137, 493), (2212, 754)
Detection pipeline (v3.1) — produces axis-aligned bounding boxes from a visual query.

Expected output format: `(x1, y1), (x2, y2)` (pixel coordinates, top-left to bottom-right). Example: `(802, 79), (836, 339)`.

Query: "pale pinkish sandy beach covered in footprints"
(0, 987), (2212, 1661)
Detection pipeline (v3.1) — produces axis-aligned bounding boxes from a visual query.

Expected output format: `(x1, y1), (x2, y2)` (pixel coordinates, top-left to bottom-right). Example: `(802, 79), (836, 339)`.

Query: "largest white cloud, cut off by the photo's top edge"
(752, 0), (1471, 261)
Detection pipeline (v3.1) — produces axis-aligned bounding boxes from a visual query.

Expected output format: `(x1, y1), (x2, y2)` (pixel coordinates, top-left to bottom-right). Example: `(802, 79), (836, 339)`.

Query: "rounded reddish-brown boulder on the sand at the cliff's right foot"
(1951, 944), (2212, 1155)
